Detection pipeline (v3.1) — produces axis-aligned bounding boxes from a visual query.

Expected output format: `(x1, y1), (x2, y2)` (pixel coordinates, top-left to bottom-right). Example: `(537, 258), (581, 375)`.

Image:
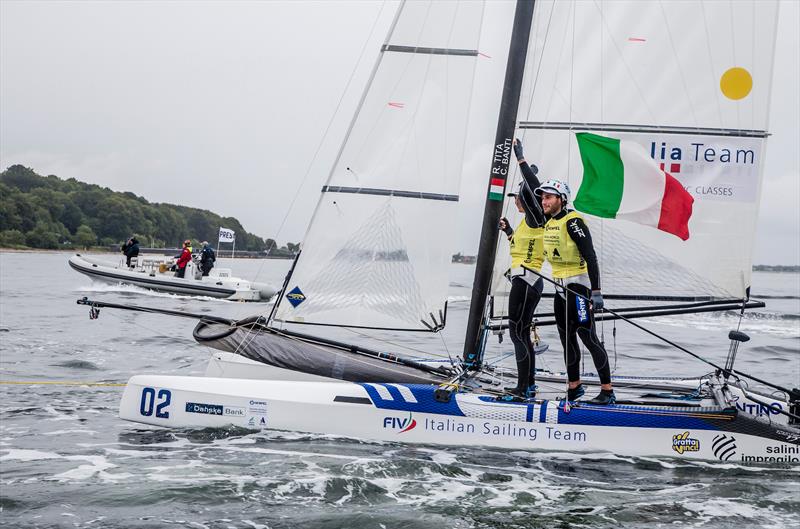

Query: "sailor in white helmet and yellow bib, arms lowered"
(535, 180), (616, 404)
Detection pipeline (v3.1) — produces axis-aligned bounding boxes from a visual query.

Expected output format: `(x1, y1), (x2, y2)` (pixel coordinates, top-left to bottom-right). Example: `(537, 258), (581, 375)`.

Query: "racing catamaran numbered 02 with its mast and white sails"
(97, 0), (800, 465)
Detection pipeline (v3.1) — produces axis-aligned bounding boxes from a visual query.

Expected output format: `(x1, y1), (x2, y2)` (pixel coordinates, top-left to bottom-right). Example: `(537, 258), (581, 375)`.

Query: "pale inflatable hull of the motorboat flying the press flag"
(69, 254), (276, 301)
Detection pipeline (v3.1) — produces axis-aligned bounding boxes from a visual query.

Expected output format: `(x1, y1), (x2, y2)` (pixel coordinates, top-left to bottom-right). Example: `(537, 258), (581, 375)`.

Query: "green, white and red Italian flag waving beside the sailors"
(575, 132), (694, 241)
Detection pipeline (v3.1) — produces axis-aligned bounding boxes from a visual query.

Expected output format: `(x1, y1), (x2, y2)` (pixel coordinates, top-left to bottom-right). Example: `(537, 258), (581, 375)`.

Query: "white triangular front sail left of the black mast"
(274, 0), (483, 330)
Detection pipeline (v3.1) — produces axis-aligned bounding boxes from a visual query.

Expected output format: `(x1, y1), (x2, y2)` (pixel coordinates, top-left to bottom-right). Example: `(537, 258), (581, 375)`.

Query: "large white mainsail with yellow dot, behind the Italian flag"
(494, 0), (778, 304)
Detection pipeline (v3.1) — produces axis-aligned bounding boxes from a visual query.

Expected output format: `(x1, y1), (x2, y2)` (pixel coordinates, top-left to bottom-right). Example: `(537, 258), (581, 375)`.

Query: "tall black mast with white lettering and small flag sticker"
(464, 0), (534, 369)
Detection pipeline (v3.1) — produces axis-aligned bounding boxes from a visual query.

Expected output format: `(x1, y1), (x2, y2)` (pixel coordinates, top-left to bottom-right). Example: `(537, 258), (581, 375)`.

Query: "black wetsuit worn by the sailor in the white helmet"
(553, 209), (611, 384)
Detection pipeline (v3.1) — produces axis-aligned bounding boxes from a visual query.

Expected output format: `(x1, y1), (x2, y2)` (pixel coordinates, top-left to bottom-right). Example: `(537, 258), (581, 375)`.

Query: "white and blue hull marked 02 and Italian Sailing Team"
(120, 375), (800, 465)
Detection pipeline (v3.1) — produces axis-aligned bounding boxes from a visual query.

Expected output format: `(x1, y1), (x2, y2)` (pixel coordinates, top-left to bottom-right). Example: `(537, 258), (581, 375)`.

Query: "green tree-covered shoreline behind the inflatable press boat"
(0, 165), (299, 256)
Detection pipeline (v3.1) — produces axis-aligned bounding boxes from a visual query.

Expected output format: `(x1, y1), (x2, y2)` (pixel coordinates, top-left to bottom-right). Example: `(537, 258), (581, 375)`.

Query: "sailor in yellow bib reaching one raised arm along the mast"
(499, 140), (546, 398)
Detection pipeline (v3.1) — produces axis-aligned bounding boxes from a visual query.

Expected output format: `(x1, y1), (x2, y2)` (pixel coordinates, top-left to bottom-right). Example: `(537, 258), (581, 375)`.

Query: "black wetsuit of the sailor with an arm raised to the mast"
(508, 161), (547, 391)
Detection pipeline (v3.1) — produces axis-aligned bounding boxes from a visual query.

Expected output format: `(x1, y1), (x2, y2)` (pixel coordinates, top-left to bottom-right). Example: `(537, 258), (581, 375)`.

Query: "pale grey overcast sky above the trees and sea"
(0, 0), (800, 264)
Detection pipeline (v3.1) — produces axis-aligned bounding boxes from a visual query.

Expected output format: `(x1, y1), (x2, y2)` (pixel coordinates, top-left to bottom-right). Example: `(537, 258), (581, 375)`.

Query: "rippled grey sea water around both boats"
(0, 253), (800, 529)
